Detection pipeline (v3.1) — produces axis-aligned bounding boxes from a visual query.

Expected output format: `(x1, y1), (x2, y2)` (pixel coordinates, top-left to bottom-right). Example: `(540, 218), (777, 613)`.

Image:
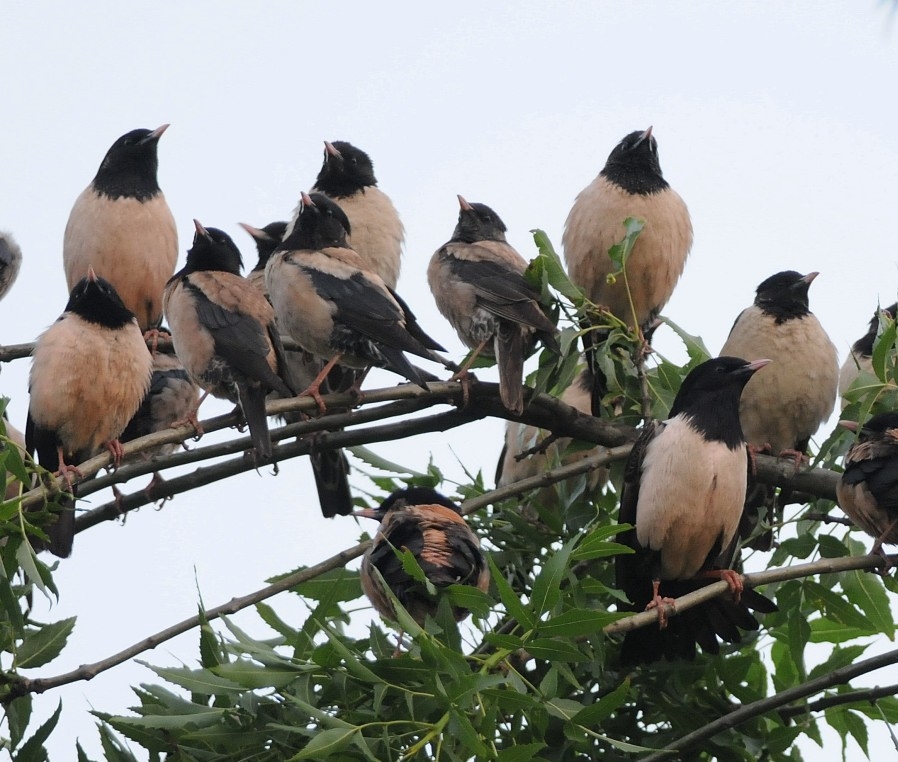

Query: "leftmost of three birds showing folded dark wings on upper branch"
(164, 220), (294, 461)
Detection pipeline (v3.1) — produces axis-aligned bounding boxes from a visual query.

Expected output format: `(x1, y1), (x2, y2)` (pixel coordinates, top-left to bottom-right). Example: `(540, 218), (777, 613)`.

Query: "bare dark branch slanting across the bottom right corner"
(642, 649), (898, 762)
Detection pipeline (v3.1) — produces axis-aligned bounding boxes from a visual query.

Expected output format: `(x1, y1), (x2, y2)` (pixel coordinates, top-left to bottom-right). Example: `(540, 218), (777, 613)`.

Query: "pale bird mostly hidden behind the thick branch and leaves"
(496, 368), (608, 508)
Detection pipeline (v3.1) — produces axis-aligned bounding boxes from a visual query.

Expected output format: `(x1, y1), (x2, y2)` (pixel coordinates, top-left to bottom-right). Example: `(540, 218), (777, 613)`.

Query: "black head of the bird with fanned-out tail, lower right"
(669, 357), (770, 449)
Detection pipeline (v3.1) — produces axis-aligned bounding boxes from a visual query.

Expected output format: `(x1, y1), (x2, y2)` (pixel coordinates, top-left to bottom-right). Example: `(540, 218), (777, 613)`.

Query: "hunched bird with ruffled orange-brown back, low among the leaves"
(355, 487), (490, 627)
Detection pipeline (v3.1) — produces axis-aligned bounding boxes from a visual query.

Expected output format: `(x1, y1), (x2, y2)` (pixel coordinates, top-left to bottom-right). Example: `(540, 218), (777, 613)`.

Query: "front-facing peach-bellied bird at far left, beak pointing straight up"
(25, 267), (153, 558)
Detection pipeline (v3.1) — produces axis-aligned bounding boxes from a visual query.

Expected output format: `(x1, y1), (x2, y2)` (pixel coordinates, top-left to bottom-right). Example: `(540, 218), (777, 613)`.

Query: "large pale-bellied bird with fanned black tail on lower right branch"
(615, 357), (770, 664)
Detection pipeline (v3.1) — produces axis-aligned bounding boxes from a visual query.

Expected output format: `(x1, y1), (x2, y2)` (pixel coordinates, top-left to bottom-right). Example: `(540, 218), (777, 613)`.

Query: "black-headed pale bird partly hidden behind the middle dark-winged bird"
(312, 140), (405, 289)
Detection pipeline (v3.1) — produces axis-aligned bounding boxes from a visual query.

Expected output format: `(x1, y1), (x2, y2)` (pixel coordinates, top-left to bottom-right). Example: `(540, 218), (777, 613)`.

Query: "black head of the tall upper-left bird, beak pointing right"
(93, 124), (168, 201)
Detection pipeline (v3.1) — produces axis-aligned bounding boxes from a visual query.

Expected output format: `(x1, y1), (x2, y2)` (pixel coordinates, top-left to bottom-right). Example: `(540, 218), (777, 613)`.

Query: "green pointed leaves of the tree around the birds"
(0, 233), (898, 762)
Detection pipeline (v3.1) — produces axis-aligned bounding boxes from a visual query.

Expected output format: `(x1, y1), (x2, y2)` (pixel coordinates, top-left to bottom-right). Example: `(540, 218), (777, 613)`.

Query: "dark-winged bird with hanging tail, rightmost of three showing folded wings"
(427, 196), (558, 414)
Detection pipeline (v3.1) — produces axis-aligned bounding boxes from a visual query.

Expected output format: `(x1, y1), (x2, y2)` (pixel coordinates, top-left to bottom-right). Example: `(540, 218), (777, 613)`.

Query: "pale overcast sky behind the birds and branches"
(0, 0), (898, 760)
